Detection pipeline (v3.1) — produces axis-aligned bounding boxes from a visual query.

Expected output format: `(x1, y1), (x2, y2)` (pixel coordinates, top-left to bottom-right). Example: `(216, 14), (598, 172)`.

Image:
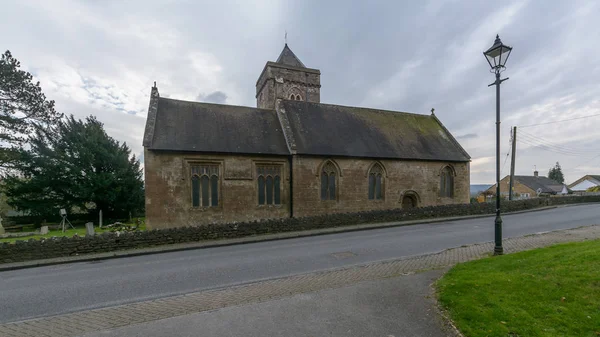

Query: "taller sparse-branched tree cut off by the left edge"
(0, 51), (62, 170)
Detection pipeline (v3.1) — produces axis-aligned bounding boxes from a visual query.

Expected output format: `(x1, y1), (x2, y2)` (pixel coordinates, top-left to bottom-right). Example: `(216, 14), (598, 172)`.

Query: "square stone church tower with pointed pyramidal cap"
(256, 43), (321, 109)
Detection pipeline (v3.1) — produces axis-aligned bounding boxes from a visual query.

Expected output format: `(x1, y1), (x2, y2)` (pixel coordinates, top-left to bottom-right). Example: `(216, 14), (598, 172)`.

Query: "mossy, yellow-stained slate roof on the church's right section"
(278, 100), (470, 162)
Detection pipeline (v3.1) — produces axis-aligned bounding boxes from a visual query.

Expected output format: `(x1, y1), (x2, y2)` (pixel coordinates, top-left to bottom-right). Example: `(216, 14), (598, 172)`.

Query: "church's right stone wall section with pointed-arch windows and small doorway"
(293, 156), (470, 217)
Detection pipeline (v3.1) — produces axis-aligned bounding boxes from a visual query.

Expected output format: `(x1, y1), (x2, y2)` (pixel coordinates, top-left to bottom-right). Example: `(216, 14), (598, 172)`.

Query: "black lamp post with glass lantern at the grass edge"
(483, 35), (512, 255)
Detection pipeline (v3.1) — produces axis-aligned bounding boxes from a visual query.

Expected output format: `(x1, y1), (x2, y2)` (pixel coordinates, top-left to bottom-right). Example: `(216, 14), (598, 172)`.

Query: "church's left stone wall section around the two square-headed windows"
(144, 150), (290, 229)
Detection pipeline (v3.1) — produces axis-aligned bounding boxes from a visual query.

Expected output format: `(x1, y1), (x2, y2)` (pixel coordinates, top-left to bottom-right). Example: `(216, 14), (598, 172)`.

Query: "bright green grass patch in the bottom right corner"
(437, 240), (600, 337)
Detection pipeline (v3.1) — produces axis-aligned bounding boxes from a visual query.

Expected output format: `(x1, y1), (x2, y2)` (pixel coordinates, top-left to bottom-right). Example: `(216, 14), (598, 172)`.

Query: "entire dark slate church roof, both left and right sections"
(144, 94), (470, 162)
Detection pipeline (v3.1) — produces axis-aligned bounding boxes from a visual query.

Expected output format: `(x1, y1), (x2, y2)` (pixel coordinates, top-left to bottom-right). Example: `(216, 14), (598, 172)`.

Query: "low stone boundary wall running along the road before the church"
(0, 196), (600, 263)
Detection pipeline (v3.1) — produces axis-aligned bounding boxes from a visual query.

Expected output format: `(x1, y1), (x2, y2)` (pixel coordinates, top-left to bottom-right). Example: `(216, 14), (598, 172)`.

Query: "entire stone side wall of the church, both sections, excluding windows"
(144, 150), (469, 229)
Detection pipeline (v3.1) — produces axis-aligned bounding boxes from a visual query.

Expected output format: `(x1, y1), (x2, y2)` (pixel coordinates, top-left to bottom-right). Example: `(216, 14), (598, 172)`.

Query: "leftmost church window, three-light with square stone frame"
(192, 165), (219, 207)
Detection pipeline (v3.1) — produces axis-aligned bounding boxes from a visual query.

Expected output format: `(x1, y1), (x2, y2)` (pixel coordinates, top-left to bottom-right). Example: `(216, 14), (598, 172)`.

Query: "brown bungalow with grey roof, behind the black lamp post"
(483, 171), (569, 199)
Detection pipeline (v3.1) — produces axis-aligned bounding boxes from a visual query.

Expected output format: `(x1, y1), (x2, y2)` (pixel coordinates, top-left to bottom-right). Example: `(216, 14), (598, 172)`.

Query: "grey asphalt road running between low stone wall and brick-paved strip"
(0, 204), (600, 323)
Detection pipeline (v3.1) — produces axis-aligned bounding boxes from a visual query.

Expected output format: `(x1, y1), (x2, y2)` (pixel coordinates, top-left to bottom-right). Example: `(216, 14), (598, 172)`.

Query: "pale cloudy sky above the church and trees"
(0, 0), (600, 184)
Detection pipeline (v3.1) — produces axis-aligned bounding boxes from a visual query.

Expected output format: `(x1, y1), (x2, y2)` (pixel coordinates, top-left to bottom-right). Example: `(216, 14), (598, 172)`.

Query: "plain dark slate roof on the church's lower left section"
(149, 97), (289, 155)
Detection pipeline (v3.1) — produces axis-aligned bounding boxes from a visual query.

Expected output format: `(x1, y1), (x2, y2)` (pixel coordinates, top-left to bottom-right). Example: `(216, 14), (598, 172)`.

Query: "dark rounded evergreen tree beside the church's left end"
(5, 116), (144, 218)
